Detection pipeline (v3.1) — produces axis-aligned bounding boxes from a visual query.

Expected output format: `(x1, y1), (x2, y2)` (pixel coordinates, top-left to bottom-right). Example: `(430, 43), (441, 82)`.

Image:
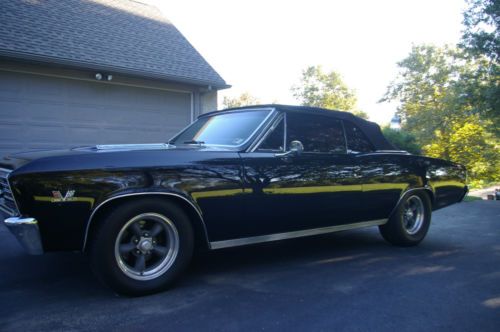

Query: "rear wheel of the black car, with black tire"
(379, 191), (432, 247)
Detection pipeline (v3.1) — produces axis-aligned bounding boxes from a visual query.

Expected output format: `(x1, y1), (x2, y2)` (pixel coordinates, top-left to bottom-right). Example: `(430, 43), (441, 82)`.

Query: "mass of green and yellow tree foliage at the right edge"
(382, 0), (500, 185)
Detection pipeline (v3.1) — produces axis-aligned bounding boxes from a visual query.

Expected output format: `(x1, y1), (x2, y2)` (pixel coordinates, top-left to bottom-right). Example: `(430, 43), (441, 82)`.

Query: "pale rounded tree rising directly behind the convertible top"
(291, 66), (368, 118)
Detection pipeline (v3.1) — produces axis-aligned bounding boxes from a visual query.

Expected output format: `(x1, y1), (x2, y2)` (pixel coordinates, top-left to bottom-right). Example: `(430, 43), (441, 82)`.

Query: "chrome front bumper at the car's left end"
(4, 217), (43, 255)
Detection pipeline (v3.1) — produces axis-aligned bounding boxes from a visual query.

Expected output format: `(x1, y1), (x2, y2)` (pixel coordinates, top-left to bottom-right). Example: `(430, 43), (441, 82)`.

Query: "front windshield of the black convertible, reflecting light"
(169, 110), (271, 147)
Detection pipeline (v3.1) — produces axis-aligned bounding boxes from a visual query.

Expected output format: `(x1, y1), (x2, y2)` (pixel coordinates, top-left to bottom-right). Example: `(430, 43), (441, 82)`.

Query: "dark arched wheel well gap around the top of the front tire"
(83, 194), (209, 252)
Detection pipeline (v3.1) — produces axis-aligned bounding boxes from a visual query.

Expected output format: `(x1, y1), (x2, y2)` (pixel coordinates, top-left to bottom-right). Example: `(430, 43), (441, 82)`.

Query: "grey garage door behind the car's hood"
(0, 71), (191, 156)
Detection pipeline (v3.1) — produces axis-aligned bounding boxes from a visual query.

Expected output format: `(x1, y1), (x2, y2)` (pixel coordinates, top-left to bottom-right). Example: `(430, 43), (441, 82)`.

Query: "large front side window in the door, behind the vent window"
(287, 113), (346, 153)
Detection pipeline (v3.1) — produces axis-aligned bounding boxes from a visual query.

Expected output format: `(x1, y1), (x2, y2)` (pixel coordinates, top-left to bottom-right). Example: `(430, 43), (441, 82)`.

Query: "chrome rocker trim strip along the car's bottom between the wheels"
(210, 219), (387, 249)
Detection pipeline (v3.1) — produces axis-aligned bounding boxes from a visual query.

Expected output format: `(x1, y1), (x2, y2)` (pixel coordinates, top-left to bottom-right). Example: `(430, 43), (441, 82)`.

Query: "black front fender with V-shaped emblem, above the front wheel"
(10, 169), (221, 251)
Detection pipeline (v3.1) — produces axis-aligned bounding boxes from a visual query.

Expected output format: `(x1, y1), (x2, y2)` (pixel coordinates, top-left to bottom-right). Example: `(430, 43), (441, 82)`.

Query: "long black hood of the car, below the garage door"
(0, 143), (237, 174)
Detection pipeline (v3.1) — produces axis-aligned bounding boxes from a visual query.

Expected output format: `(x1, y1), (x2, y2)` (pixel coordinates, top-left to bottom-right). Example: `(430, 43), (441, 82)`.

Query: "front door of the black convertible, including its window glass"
(236, 112), (363, 236)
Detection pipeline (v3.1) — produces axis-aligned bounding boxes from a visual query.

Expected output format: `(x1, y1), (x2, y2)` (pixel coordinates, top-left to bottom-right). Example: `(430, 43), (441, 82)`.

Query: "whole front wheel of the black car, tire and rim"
(89, 198), (194, 296)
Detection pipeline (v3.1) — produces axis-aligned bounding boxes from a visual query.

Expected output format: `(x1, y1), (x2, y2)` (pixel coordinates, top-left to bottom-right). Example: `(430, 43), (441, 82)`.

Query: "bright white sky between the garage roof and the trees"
(142, 0), (465, 124)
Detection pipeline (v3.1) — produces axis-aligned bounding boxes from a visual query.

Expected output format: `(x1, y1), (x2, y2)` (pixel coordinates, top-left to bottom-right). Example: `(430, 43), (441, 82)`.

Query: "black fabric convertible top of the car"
(200, 104), (397, 150)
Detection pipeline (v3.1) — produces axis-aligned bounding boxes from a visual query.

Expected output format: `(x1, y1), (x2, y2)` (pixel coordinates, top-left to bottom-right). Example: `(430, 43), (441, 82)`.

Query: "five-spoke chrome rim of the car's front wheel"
(115, 213), (179, 280)
